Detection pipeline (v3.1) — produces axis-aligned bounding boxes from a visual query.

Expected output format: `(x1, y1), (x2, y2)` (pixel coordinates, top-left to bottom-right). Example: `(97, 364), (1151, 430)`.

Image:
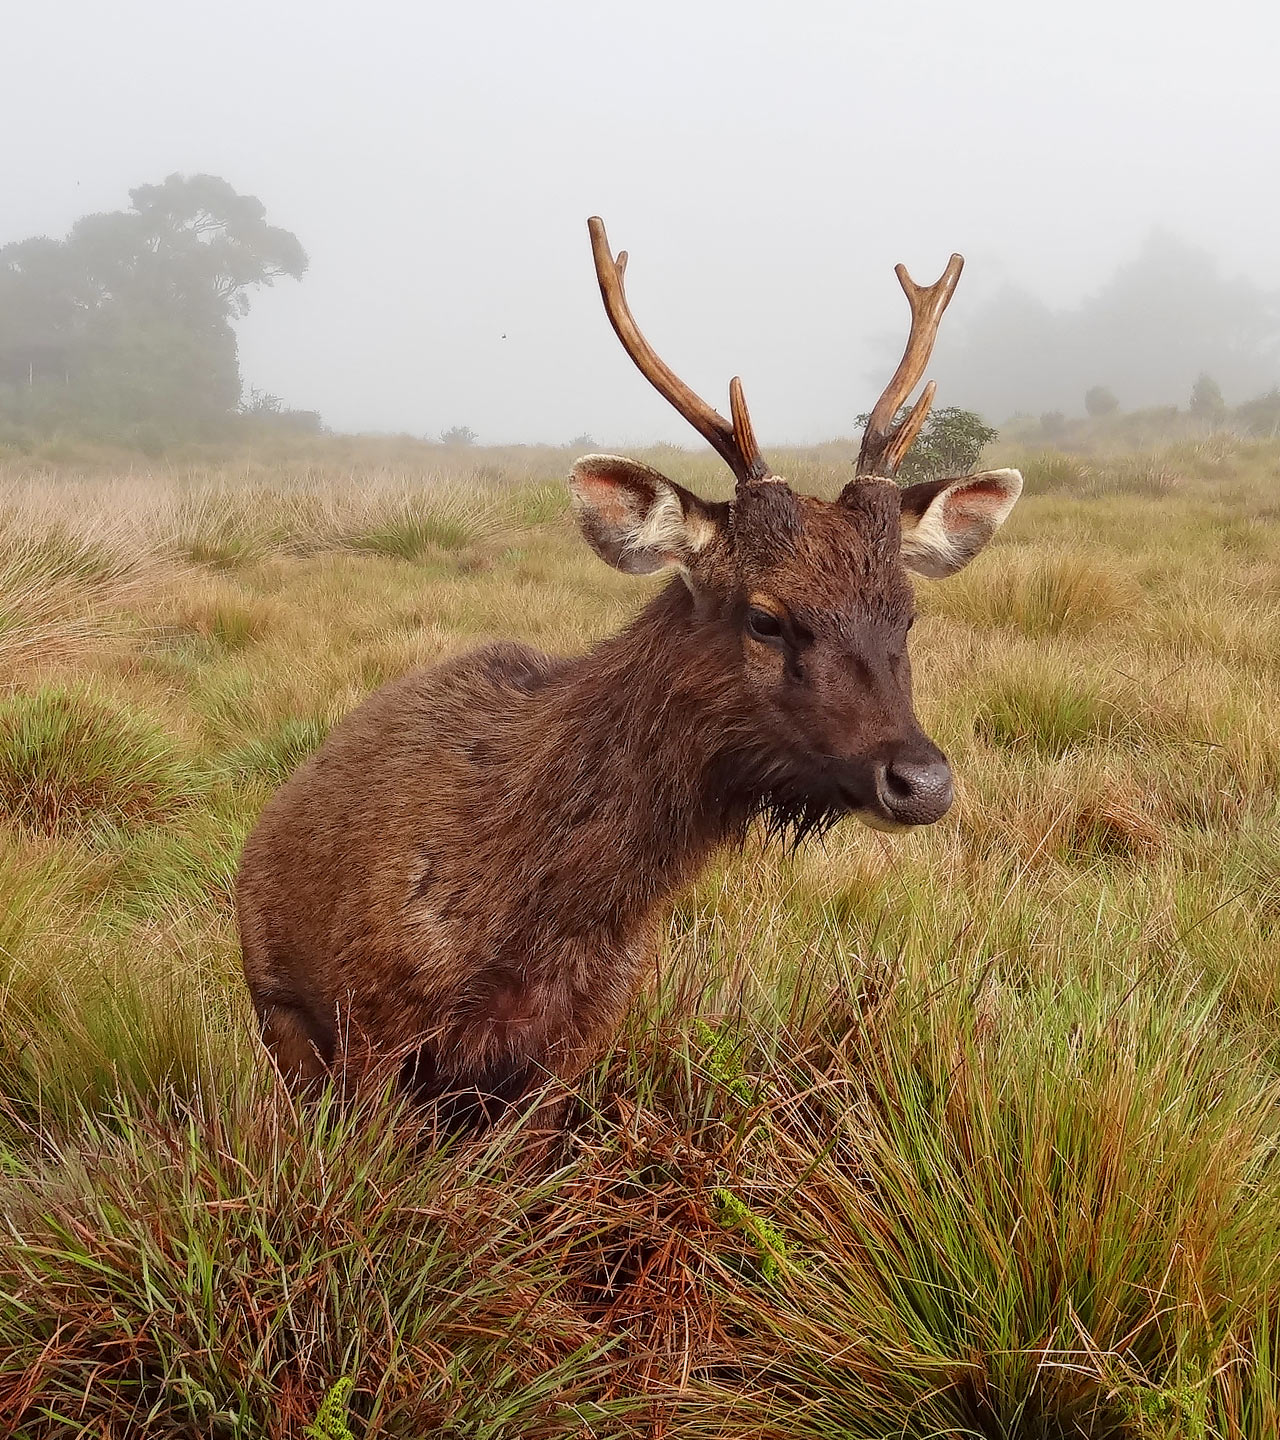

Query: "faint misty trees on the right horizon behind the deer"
(936, 232), (1280, 420)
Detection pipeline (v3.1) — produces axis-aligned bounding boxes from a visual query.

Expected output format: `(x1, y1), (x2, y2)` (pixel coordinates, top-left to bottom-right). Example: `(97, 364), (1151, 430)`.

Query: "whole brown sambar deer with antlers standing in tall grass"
(238, 217), (1022, 1125)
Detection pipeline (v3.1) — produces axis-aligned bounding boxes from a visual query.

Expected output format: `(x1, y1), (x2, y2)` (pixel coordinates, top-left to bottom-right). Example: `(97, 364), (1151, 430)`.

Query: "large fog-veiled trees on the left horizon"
(0, 174), (320, 446)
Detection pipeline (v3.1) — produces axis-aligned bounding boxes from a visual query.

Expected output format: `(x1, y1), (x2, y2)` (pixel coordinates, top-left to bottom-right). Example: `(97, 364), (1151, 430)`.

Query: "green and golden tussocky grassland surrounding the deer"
(0, 441), (1280, 1440)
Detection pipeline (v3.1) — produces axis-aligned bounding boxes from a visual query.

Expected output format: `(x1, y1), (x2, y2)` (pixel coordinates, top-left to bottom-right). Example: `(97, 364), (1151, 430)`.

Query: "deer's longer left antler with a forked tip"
(586, 215), (773, 485)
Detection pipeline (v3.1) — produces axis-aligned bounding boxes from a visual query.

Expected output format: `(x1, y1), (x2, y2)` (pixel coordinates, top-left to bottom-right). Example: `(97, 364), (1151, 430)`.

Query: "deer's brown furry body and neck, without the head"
(238, 586), (740, 1099)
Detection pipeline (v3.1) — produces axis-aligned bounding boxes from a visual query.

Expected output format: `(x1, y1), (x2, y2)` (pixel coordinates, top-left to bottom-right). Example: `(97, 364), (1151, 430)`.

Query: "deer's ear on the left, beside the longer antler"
(569, 455), (724, 575)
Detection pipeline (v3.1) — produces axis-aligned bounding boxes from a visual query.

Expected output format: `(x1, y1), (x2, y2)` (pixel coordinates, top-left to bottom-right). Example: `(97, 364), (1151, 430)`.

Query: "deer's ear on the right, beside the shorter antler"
(901, 469), (1022, 580)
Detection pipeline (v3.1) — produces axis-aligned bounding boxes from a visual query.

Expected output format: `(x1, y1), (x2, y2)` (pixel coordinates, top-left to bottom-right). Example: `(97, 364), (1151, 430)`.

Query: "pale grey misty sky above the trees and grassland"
(0, 0), (1280, 444)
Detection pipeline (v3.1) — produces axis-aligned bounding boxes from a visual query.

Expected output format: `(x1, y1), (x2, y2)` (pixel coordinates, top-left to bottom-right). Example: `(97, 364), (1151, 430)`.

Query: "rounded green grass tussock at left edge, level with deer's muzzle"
(0, 688), (202, 835)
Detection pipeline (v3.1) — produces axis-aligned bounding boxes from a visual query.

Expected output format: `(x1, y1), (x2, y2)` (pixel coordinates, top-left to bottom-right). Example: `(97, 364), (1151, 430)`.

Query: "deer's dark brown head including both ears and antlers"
(570, 217), (1022, 829)
